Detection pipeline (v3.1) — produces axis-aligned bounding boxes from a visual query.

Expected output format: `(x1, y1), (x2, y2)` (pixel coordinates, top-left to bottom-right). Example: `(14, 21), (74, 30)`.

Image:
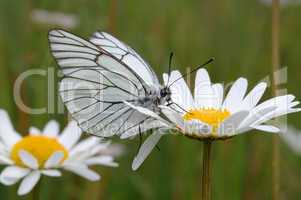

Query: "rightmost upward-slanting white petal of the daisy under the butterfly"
(240, 82), (267, 110)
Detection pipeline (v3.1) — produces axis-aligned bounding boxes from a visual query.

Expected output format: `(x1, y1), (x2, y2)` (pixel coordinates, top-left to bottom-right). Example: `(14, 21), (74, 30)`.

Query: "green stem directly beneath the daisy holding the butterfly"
(202, 141), (212, 200)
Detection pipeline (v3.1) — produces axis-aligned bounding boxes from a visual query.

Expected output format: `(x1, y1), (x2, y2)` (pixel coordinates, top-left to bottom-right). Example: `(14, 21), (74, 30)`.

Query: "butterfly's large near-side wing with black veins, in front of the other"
(49, 30), (164, 137)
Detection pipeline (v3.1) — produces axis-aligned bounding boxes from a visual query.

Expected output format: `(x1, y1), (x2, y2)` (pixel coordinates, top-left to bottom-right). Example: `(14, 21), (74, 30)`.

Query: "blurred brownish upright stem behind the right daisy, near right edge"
(272, 0), (280, 200)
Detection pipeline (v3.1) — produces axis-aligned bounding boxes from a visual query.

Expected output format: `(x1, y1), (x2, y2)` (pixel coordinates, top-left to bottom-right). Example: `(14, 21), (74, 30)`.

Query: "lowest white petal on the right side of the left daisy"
(64, 165), (101, 181)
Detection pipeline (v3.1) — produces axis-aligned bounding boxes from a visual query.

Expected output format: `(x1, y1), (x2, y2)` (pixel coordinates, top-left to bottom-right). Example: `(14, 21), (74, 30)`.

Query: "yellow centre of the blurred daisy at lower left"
(10, 135), (68, 167)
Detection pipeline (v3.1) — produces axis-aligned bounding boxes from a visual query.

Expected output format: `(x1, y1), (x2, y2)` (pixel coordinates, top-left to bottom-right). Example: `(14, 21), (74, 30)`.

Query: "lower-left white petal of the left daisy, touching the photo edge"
(0, 166), (30, 185)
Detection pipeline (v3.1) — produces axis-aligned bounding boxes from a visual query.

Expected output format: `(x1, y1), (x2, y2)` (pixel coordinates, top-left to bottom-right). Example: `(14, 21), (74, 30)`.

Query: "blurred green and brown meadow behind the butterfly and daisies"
(0, 0), (301, 200)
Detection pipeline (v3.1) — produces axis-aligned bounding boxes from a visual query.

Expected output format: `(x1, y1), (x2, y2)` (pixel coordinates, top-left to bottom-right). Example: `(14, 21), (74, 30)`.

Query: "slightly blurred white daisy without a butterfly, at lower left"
(0, 110), (118, 195)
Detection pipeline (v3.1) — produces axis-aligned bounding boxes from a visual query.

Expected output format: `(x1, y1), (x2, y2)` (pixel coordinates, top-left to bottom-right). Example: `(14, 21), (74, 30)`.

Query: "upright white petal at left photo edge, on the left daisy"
(0, 110), (21, 147)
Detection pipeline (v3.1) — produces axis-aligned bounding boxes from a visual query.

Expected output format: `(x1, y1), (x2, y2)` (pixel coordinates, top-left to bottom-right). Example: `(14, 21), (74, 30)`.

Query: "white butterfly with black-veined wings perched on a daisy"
(49, 30), (171, 141)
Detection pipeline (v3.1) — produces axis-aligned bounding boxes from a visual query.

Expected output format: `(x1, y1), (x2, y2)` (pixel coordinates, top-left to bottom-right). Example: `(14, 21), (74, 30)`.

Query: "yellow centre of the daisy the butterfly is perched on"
(183, 108), (231, 135)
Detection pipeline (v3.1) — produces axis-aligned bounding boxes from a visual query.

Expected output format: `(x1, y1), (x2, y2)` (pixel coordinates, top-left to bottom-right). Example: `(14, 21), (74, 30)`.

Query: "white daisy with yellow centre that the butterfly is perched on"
(127, 69), (300, 170)
